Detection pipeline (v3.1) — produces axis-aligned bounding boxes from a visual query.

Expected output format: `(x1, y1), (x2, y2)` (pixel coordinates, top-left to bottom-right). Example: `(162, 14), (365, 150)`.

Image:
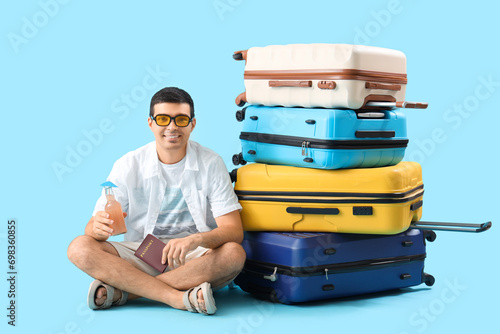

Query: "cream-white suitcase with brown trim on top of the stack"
(233, 44), (427, 109)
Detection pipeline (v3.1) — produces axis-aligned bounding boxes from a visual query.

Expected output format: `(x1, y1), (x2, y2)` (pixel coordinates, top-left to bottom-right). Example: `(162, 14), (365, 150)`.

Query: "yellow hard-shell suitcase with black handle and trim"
(232, 161), (424, 234)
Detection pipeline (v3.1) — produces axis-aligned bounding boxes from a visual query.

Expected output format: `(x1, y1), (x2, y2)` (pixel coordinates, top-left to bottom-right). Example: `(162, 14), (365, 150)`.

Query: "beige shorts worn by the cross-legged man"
(108, 239), (234, 291)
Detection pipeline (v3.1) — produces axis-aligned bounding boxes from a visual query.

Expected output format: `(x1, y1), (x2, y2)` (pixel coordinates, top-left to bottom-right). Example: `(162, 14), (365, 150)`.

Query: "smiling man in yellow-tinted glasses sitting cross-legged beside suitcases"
(68, 87), (245, 314)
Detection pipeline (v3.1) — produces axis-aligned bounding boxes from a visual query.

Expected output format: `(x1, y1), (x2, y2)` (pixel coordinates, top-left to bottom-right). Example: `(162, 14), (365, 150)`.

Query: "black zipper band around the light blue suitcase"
(240, 132), (408, 149)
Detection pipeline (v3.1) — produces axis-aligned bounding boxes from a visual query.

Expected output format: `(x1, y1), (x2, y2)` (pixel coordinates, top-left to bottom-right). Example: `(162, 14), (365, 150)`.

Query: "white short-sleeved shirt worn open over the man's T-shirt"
(93, 141), (241, 241)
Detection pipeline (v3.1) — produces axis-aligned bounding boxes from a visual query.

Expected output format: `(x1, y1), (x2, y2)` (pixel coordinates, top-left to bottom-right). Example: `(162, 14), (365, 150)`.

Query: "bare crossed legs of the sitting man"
(68, 235), (245, 310)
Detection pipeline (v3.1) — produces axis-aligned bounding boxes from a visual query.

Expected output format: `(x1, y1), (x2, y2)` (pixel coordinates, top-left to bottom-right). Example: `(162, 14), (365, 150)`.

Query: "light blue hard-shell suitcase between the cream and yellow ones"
(233, 105), (408, 169)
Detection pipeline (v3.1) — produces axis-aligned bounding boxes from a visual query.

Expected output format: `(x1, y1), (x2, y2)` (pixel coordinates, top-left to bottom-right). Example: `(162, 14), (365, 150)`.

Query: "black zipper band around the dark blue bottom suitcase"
(243, 254), (426, 282)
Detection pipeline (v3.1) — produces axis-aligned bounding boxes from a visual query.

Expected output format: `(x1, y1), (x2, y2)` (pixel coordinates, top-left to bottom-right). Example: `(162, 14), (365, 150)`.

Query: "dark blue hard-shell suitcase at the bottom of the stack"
(234, 229), (436, 304)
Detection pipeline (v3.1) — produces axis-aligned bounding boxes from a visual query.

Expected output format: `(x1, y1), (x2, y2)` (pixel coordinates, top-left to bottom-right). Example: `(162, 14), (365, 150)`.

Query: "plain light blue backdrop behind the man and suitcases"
(0, 0), (500, 334)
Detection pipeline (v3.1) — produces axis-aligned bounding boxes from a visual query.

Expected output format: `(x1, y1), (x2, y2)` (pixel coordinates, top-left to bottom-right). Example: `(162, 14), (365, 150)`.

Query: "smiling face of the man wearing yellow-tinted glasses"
(148, 103), (196, 151)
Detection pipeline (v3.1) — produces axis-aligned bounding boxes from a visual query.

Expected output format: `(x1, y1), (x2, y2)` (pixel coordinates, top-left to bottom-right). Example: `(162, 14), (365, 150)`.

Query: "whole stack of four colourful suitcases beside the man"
(231, 44), (491, 304)
